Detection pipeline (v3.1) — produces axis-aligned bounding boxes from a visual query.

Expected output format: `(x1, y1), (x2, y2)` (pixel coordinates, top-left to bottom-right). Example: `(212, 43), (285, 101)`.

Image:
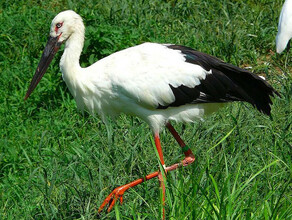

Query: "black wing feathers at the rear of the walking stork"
(158, 45), (279, 115)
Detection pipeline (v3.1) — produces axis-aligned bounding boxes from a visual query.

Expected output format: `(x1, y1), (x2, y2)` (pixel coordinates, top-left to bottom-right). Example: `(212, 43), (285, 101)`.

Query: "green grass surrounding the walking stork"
(0, 0), (292, 220)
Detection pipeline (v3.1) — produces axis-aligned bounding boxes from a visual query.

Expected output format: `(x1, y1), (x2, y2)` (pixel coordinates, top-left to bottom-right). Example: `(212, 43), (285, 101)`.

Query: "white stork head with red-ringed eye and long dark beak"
(24, 10), (84, 100)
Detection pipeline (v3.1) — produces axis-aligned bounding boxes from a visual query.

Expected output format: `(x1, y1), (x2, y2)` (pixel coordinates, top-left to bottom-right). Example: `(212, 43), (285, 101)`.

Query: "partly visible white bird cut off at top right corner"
(276, 0), (292, 53)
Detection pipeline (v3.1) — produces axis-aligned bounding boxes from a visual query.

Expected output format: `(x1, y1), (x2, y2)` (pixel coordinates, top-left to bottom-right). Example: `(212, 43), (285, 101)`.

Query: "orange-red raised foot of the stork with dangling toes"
(98, 184), (130, 212)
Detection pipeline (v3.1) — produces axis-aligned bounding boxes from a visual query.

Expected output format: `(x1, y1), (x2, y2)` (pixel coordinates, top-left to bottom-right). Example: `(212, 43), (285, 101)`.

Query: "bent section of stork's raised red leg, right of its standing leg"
(166, 122), (195, 168)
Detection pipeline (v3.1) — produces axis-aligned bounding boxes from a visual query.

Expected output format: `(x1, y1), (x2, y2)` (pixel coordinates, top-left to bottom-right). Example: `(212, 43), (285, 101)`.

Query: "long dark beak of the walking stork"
(24, 36), (62, 100)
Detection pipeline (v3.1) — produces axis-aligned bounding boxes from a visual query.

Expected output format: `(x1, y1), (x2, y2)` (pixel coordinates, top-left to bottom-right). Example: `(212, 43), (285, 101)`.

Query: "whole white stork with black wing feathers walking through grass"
(24, 10), (279, 219)
